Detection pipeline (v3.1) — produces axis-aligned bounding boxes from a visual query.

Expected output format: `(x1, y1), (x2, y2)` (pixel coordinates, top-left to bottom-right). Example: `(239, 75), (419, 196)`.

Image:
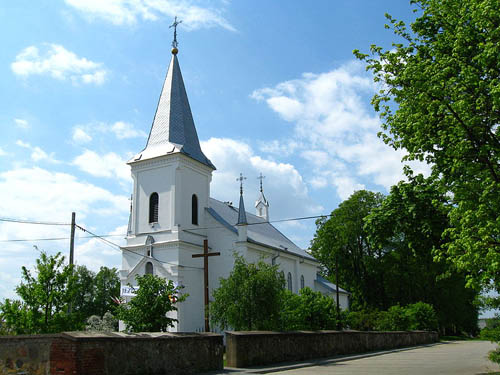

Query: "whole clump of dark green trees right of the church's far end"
(311, 184), (477, 333)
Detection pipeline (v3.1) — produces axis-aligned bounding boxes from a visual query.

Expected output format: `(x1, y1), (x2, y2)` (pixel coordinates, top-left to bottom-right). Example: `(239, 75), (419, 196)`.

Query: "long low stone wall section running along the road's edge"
(226, 331), (438, 367)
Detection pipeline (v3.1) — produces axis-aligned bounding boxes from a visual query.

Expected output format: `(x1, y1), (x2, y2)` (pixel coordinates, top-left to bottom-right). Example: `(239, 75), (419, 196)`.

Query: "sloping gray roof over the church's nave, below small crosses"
(207, 198), (316, 260)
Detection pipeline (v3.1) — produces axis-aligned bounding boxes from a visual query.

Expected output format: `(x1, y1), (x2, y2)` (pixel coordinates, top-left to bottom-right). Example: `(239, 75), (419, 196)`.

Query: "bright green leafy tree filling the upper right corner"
(354, 0), (500, 296)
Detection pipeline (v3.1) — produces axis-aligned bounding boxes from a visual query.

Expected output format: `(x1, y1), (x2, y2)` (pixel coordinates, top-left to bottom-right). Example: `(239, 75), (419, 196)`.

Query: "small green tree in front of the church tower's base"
(117, 275), (187, 332)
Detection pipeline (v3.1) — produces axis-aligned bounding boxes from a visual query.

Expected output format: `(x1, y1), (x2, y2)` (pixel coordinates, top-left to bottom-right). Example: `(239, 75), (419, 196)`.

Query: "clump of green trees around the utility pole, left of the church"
(0, 252), (120, 334)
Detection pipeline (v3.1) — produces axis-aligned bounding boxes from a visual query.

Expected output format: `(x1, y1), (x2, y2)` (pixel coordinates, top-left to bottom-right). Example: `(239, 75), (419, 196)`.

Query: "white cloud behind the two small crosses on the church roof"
(201, 138), (323, 220)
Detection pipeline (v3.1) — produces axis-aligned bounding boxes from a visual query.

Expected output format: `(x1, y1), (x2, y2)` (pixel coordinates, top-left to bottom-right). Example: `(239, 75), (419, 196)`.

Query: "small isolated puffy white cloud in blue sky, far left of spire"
(10, 44), (107, 85)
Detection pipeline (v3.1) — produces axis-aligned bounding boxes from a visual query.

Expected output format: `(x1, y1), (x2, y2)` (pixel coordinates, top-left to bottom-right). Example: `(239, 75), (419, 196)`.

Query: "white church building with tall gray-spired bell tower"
(120, 42), (349, 332)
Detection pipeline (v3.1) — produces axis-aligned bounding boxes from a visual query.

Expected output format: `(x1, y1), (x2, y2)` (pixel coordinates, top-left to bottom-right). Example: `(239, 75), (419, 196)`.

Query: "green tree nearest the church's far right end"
(311, 190), (386, 310)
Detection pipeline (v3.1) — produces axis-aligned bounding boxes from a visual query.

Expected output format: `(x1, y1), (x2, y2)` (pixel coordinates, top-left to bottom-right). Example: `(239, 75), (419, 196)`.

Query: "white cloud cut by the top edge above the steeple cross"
(65, 0), (235, 31)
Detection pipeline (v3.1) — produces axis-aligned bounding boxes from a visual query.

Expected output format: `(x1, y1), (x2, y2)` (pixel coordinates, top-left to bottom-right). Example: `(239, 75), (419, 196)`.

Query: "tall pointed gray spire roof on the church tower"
(129, 55), (215, 169)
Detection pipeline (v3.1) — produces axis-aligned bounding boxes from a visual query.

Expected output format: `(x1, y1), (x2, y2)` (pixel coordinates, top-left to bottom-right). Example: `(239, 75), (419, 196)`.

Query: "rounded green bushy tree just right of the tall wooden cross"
(210, 255), (285, 331)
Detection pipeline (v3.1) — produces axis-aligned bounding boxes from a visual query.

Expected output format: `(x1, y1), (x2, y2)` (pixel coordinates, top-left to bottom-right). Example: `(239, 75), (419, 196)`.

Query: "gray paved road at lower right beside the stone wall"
(266, 341), (500, 375)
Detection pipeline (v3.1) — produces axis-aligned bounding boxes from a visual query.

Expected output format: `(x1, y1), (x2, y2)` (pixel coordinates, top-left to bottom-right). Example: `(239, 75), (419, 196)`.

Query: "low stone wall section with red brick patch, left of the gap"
(0, 332), (223, 375)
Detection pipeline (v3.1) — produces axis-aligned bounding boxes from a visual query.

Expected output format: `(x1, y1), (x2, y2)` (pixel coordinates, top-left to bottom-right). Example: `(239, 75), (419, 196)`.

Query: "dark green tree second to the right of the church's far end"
(365, 174), (478, 334)
